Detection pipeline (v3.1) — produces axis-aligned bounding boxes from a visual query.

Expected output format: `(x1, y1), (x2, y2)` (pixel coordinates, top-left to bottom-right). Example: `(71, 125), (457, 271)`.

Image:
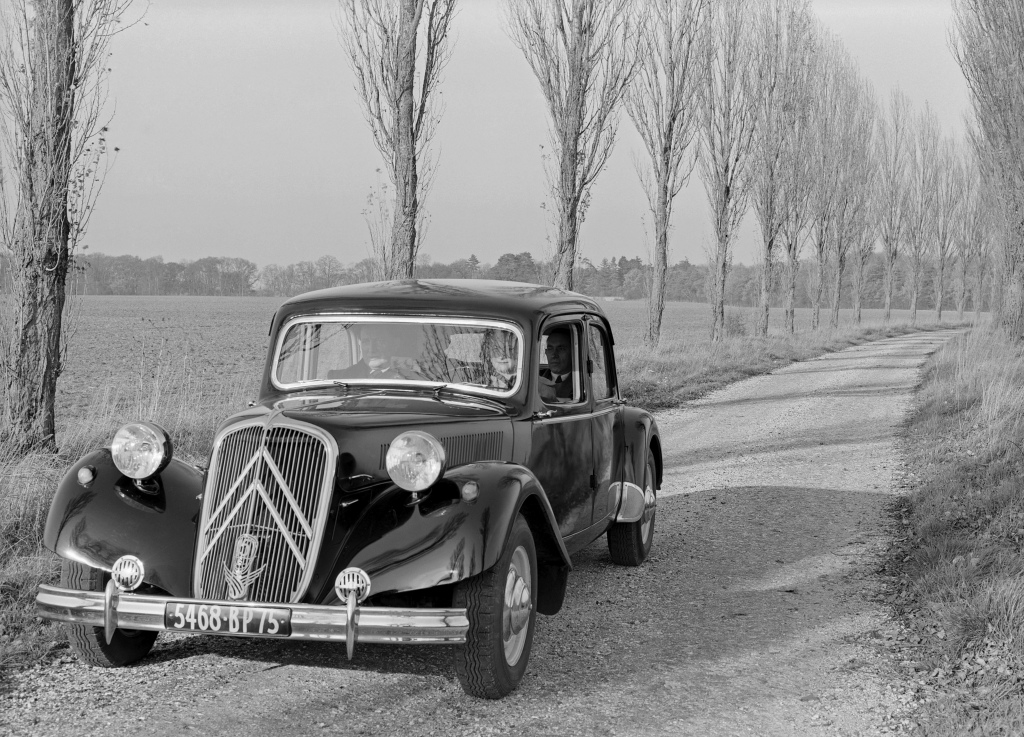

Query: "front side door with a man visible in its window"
(529, 317), (594, 540)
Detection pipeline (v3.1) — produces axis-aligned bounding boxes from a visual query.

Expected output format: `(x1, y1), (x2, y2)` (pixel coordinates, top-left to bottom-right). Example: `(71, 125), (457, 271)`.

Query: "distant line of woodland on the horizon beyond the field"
(0, 253), (978, 309)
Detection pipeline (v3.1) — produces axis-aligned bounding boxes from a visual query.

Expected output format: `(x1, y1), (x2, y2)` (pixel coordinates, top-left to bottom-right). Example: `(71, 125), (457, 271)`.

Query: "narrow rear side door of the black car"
(586, 317), (625, 524)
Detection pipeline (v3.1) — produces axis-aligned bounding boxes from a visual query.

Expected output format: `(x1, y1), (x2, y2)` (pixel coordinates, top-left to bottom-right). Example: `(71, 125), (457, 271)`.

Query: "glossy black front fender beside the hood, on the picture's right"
(325, 463), (571, 614)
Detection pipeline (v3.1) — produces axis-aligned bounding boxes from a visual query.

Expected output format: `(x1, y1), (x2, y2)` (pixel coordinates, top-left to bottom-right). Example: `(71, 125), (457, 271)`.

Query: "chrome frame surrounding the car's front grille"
(193, 413), (339, 603)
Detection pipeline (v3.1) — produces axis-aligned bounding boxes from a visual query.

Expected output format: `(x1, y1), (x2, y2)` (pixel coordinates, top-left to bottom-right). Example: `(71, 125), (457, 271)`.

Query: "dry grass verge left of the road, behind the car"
(0, 312), (954, 678)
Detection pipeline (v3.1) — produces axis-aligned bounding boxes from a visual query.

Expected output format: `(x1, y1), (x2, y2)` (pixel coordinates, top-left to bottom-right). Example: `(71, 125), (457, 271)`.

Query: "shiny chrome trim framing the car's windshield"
(270, 312), (526, 399)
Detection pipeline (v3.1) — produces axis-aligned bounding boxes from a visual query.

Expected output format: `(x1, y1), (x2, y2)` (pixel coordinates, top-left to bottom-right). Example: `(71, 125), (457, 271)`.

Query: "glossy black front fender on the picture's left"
(43, 448), (203, 597)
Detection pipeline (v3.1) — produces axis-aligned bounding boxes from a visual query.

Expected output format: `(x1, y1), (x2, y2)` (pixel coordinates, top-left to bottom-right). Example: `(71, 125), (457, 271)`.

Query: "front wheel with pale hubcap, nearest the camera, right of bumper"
(454, 516), (537, 699)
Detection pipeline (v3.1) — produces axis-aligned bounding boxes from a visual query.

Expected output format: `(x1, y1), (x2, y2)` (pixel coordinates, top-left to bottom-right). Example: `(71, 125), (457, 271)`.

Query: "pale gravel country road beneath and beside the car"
(0, 333), (952, 737)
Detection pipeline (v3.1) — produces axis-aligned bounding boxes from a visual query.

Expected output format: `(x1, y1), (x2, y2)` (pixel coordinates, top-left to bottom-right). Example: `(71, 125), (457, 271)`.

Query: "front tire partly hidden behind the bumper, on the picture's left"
(60, 560), (157, 667)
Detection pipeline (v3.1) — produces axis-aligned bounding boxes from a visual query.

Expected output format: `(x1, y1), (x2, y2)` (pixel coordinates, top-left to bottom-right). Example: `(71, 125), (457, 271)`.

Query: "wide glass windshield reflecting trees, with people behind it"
(273, 316), (522, 396)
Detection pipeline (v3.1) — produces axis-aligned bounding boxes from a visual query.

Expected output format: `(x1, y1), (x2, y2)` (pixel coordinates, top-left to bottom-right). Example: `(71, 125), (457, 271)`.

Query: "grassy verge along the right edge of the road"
(892, 330), (1024, 735)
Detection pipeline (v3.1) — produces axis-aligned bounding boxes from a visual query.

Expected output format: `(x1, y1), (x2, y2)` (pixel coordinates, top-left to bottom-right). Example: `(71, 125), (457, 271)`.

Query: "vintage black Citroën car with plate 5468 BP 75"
(37, 279), (662, 698)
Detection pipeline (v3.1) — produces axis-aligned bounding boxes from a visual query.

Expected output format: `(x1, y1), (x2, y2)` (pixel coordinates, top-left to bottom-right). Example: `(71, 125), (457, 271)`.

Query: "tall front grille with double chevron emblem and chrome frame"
(194, 421), (337, 603)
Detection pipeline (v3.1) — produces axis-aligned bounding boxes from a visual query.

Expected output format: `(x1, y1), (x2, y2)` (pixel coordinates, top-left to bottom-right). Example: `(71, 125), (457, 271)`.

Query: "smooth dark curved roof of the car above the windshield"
(278, 279), (604, 324)
